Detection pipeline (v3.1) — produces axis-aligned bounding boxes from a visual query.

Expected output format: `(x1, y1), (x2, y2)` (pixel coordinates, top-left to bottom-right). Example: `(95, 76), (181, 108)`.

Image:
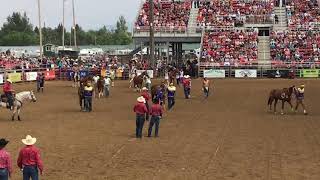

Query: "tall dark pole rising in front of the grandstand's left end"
(149, 0), (155, 69)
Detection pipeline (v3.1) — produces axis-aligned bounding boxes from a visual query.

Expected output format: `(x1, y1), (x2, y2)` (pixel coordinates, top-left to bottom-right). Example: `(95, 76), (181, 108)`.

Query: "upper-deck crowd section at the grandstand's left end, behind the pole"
(135, 0), (191, 31)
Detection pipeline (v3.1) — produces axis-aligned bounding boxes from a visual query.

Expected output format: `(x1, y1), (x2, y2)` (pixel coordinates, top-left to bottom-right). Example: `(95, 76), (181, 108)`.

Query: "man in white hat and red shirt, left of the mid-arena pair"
(133, 96), (148, 138)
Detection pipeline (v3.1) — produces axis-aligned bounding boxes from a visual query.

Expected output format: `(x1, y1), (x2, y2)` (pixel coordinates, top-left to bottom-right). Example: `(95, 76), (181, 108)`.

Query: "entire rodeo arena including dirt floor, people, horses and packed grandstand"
(0, 0), (320, 180)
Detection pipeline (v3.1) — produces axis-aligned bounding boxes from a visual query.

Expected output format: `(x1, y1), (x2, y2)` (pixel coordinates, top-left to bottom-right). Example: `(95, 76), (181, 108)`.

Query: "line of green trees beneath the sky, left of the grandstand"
(0, 12), (132, 46)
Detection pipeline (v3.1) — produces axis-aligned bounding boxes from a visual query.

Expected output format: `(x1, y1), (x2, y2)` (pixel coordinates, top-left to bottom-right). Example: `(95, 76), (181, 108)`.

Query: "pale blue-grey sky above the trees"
(0, 0), (141, 30)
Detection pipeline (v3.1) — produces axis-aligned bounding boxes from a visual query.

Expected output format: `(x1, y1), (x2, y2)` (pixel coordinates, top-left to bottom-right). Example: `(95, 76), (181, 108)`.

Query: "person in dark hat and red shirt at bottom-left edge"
(0, 139), (12, 180)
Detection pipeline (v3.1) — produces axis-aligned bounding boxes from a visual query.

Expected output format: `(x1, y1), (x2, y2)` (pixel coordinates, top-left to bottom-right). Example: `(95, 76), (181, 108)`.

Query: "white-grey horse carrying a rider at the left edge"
(0, 91), (37, 121)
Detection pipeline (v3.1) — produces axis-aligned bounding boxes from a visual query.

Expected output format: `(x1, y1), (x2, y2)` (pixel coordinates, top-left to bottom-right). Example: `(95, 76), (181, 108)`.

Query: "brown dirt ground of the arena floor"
(0, 80), (320, 180)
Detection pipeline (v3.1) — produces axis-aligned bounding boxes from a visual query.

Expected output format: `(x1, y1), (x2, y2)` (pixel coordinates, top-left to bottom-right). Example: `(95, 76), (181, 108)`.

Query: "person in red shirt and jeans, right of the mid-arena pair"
(148, 100), (163, 137)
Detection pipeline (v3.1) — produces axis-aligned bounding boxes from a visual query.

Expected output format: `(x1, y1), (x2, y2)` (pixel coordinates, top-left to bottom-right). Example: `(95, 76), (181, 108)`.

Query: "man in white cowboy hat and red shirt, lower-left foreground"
(17, 135), (43, 180)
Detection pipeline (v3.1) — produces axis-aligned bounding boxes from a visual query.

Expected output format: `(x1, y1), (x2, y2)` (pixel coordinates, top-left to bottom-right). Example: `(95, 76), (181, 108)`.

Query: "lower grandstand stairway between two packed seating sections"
(258, 36), (271, 68)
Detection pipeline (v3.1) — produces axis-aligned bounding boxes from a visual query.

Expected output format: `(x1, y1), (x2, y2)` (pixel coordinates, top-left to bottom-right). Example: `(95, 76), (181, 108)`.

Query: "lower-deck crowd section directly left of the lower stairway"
(201, 29), (258, 66)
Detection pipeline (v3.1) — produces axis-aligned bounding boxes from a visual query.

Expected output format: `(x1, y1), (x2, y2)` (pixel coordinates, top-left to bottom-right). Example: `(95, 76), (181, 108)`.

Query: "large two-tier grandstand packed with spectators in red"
(133, 0), (320, 74)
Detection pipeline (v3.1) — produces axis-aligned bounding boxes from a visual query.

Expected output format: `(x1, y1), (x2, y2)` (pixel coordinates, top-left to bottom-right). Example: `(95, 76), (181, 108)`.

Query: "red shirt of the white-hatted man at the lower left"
(17, 146), (43, 173)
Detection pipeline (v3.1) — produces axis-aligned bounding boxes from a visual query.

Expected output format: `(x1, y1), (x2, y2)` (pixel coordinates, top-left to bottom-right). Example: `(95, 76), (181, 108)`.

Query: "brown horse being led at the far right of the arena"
(268, 86), (295, 114)
